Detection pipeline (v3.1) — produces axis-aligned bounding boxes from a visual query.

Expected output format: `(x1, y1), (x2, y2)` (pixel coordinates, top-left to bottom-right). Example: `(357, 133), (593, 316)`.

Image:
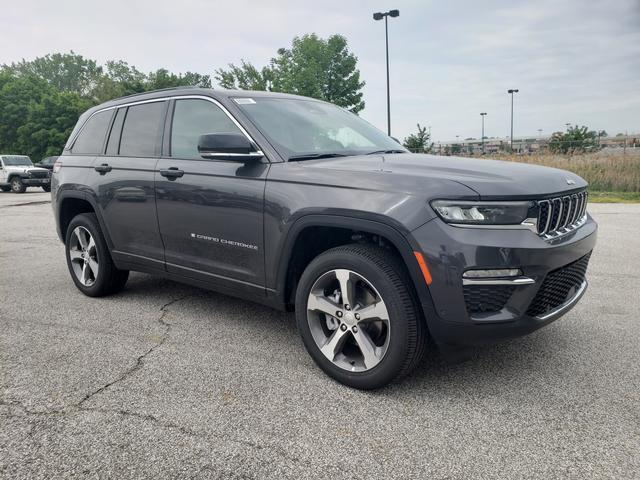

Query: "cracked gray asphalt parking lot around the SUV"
(0, 189), (640, 479)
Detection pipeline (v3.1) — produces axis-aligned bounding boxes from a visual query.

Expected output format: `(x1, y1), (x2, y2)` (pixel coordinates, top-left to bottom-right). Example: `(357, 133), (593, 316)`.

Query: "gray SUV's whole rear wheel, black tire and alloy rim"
(65, 213), (129, 297)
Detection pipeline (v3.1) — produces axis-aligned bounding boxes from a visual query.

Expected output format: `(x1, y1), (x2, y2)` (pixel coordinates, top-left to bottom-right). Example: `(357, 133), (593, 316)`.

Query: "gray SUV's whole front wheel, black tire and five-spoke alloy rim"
(295, 245), (427, 390)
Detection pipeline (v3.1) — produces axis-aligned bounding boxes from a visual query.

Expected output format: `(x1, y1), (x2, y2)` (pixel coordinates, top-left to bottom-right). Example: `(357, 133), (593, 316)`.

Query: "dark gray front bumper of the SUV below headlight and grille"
(412, 217), (597, 345)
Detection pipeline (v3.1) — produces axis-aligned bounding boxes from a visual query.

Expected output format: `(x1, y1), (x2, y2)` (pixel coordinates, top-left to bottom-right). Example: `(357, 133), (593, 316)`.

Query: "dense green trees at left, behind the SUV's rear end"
(0, 52), (211, 161)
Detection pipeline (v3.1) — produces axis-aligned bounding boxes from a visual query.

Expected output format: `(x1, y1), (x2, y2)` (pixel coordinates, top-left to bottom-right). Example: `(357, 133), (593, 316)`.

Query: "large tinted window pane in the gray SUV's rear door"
(120, 102), (165, 157)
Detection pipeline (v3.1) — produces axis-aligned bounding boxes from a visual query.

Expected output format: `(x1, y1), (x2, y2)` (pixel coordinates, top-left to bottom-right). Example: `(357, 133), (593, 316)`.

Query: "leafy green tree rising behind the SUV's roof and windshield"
(215, 34), (364, 113)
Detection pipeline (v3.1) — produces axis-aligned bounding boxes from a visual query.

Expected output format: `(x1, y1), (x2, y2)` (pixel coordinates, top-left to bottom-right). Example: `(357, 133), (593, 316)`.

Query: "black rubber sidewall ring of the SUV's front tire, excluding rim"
(296, 252), (408, 389)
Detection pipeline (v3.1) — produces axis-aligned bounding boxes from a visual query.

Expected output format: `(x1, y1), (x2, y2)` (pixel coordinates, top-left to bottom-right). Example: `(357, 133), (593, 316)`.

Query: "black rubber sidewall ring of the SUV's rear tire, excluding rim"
(64, 214), (111, 297)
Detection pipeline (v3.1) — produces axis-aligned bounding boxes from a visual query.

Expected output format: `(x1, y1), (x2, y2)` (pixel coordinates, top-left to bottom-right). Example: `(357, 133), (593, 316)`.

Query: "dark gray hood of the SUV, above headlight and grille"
(301, 153), (587, 199)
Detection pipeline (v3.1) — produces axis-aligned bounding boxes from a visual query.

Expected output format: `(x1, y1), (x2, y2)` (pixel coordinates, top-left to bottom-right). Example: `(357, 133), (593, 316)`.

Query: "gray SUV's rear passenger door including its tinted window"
(90, 100), (168, 269)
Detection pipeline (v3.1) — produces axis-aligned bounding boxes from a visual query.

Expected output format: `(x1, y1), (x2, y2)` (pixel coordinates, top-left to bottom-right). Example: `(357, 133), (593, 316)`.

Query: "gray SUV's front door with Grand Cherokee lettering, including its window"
(156, 98), (269, 293)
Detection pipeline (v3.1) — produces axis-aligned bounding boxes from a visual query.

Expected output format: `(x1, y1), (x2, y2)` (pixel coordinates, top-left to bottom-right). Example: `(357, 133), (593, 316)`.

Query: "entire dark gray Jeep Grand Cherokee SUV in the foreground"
(52, 88), (597, 388)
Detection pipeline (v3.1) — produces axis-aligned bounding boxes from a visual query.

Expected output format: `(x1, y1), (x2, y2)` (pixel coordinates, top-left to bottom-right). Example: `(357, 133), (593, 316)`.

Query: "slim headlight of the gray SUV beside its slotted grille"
(431, 200), (533, 225)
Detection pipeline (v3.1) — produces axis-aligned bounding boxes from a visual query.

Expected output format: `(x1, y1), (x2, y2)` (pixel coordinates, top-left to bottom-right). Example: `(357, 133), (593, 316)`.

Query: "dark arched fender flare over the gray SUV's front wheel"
(276, 214), (433, 305)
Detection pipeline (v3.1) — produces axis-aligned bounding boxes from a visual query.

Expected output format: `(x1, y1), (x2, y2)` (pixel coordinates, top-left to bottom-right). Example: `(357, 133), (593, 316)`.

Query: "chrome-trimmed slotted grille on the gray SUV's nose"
(538, 191), (588, 236)
